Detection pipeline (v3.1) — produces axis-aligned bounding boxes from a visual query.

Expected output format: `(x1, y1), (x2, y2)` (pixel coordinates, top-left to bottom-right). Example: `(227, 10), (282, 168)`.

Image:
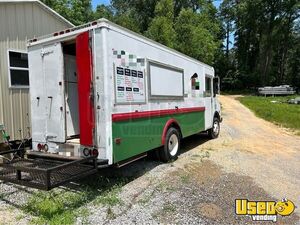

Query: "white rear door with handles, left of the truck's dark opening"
(41, 43), (66, 143)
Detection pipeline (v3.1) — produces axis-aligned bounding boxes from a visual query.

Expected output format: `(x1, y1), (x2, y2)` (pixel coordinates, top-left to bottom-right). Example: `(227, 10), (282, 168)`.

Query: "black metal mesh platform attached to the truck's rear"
(0, 149), (106, 190)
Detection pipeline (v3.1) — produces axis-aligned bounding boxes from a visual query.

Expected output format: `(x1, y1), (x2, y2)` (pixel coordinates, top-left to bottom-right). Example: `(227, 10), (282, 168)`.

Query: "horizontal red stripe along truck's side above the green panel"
(112, 107), (205, 122)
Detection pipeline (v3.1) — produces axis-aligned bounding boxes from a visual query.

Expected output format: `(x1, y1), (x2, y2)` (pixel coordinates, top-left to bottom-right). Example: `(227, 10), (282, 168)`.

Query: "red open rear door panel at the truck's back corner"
(76, 31), (95, 146)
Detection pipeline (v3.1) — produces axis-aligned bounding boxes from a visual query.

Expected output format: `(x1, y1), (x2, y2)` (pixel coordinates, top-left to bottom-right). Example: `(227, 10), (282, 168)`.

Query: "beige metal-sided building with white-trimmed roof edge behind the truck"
(0, 0), (73, 139)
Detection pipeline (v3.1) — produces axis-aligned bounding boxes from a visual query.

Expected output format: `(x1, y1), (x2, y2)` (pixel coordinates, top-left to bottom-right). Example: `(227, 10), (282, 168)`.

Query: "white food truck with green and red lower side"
(0, 19), (222, 189)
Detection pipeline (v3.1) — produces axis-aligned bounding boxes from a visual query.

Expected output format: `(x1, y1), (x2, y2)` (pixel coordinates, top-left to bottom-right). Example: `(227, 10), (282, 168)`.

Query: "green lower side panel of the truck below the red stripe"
(112, 111), (205, 163)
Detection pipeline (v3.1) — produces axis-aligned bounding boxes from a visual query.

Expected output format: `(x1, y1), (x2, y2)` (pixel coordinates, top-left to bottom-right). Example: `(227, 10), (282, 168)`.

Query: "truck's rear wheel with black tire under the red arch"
(159, 127), (180, 162)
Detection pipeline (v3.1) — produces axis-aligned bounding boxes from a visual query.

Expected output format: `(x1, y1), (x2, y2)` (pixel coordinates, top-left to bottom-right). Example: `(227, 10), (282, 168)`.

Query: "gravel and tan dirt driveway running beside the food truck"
(0, 96), (300, 224)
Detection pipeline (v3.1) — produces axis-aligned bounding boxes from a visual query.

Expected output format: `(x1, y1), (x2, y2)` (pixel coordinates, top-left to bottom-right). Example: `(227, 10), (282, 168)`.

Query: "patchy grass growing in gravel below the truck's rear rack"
(22, 176), (129, 225)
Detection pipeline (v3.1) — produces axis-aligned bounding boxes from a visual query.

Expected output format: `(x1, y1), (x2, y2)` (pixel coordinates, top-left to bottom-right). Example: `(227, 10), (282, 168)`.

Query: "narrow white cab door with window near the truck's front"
(204, 75), (214, 130)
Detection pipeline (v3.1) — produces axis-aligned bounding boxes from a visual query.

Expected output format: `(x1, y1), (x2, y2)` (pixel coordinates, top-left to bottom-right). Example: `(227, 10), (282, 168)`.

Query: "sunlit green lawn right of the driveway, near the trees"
(238, 96), (300, 135)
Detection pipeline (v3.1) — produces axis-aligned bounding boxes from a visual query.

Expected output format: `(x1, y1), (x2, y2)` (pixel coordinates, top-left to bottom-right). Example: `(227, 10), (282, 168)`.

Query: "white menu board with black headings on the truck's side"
(115, 67), (146, 103)
